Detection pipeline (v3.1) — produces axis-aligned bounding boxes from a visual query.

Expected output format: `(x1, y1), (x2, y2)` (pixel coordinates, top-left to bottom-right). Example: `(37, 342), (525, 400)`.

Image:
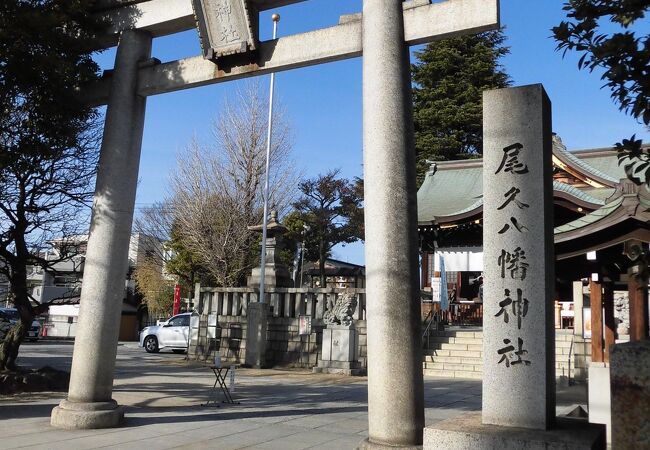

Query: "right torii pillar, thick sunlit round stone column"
(360, 0), (424, 449)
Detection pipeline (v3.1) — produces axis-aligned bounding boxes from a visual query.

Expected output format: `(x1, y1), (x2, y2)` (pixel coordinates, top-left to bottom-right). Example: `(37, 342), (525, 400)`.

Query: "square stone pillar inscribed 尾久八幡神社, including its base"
(424, 84), (605, 449)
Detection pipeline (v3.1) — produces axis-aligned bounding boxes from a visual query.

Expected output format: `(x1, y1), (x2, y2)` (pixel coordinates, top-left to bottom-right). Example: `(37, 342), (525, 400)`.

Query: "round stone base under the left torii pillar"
(50, 400), (124, 430)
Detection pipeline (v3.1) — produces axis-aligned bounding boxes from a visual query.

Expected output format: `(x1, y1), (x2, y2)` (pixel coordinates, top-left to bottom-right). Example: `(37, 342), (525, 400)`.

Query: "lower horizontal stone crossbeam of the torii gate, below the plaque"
(85, 0), (499, 105)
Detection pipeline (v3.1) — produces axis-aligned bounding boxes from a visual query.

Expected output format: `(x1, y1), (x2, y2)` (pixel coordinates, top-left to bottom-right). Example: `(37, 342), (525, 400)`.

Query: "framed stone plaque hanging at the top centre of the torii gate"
(192, 0), (258, 59)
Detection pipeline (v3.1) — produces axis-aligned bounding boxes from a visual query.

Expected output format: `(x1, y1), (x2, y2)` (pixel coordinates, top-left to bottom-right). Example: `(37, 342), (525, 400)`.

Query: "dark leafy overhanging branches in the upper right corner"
(553, 0), (650, 186)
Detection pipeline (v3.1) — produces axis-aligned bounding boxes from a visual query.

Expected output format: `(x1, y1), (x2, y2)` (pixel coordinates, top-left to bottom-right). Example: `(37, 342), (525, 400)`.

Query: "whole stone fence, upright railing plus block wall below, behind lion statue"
(190, 286), (366, 367)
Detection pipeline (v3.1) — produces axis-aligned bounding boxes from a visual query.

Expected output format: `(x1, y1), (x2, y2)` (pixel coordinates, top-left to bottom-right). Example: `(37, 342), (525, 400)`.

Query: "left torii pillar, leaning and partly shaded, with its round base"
(51, 30), (151, 429)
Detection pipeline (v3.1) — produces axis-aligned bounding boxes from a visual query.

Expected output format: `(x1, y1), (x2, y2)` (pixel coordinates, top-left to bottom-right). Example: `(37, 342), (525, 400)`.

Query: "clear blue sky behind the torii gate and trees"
(97, 0), (650, 264)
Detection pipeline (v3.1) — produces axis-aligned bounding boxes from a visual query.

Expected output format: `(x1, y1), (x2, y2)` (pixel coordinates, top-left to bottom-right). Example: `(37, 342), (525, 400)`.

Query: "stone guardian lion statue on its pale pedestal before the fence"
(313, 292), (363, 375)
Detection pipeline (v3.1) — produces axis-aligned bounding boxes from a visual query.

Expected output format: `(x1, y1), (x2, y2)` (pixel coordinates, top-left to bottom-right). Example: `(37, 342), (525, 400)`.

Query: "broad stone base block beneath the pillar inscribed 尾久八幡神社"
(424, 412), (607, 450)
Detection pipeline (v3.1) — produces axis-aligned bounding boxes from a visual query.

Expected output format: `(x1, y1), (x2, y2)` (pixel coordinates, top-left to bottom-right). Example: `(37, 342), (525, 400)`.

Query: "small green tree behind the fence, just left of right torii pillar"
(289, 169), (363, 287)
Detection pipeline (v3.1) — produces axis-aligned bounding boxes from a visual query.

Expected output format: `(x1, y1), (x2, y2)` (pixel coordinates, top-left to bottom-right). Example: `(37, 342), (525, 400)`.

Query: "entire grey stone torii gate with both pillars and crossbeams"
(51, 0), (499, 448)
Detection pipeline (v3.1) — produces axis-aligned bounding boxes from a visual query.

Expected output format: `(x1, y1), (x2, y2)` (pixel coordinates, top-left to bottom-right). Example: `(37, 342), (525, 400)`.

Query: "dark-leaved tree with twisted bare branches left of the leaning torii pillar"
(0, 0), (104, 370)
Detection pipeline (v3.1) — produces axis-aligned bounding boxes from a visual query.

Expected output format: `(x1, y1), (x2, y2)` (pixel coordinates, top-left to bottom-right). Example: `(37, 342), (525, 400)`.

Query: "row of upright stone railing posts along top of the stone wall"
(196, 286), (366, 320)
